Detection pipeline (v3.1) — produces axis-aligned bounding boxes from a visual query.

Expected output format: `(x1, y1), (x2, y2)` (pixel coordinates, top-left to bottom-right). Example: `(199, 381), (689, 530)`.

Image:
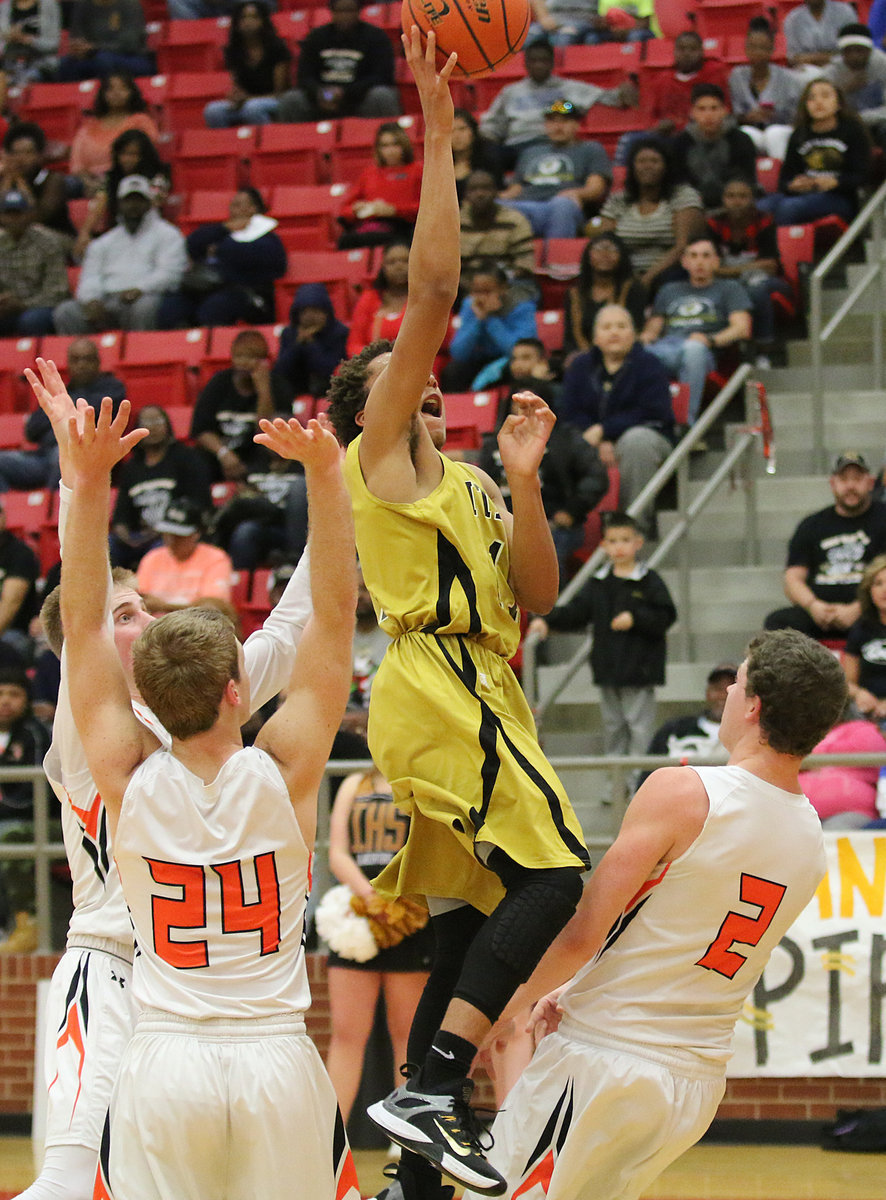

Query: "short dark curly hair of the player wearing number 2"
(744, 629), (849, 757)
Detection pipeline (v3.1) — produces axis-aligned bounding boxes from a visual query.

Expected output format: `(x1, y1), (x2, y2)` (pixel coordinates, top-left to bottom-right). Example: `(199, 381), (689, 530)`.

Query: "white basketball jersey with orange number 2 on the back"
(561, 767), (825, 1062)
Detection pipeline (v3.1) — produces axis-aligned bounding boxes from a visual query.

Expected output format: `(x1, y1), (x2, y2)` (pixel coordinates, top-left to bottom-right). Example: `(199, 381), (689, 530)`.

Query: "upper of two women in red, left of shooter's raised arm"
(339, 121), (421, 250)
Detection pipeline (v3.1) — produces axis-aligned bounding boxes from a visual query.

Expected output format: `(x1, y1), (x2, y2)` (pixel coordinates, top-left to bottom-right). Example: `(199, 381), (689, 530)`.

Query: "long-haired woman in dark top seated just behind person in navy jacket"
(563, 233), (646, 355)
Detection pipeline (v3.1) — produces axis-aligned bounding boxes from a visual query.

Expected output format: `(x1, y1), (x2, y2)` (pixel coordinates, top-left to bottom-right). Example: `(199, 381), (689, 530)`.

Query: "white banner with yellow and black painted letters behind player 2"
(729, 830), (886, 1078)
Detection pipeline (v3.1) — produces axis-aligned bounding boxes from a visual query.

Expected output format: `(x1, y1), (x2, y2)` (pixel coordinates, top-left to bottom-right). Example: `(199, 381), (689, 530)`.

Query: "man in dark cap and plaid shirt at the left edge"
(0, 191), (71, 337)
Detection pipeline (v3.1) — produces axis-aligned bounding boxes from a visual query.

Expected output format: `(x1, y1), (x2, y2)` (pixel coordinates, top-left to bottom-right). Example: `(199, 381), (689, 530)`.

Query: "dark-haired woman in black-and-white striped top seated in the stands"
(600, 138), (705, 295)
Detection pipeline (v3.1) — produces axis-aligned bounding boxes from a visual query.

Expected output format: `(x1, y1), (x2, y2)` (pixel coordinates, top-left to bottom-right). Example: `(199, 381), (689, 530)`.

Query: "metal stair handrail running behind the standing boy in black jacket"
(522, 362), (760, 730)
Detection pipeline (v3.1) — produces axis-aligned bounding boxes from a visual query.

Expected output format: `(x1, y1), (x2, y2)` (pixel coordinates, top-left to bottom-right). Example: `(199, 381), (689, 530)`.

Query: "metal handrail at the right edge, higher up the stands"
(809, 182), (886, 470)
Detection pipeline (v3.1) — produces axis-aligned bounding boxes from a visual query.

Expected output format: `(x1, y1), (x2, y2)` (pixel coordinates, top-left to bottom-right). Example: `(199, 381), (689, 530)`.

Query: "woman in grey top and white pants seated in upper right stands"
(729, 17), (803, 160)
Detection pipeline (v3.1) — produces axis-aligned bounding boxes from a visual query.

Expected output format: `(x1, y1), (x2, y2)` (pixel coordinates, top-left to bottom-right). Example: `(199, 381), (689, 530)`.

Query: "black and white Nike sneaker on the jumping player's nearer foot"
(367, 1075), (508, 1200)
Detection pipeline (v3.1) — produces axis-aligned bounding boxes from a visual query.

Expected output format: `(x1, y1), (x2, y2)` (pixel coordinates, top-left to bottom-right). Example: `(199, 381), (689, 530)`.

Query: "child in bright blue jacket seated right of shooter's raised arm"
(441, 264), (537, 391)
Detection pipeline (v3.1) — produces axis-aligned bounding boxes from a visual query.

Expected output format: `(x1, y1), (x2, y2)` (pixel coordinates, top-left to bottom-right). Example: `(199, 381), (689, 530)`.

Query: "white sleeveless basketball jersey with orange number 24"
(114, 746), (311, 1020)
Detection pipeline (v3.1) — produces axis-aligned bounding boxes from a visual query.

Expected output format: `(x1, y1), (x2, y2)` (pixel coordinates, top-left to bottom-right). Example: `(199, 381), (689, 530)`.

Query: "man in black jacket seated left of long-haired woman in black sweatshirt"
(674, 83), (756, 209)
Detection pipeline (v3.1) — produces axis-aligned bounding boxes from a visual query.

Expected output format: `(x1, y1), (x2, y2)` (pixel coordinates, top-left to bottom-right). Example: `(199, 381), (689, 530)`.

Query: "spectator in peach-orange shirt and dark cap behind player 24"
(136, 500), (233, 613)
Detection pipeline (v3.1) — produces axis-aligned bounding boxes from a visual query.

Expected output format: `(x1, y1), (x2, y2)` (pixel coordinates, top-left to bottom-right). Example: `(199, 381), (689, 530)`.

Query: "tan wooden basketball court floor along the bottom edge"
(0, 1138), (886, 1200)
